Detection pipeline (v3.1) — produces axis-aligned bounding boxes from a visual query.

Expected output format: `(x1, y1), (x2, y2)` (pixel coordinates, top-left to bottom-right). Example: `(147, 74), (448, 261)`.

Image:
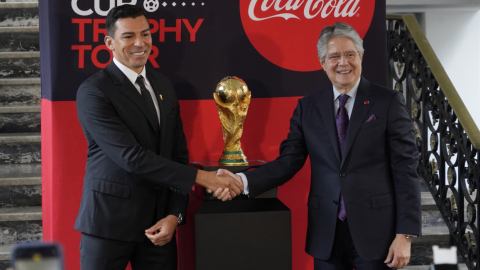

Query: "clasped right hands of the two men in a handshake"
(195, 170), (243, 200)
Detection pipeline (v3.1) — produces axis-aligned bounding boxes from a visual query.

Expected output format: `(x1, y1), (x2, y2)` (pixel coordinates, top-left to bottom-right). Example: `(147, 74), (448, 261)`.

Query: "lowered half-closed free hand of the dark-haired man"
(145, 215), (178, 246)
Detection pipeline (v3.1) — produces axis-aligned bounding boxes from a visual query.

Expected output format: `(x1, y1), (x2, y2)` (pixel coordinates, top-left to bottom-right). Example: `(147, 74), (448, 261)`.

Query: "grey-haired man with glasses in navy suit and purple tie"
(214, 23), (421, 270)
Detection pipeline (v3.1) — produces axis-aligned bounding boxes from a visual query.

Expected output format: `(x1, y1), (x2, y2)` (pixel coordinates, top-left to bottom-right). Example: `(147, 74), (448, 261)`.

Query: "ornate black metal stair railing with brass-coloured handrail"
(387, 15), (480, 270)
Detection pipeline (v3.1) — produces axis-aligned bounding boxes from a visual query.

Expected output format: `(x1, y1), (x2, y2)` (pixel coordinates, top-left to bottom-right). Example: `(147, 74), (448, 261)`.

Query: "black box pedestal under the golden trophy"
(195, 199), (292, 270)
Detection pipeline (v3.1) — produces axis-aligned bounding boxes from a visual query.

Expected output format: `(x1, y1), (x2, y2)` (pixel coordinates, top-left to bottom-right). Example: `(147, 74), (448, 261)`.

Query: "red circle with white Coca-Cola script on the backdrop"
(240, 0), (375, 71)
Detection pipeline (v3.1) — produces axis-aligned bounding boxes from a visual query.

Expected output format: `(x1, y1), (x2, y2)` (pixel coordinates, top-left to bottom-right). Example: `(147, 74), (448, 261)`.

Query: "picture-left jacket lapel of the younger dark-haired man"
(107, 61), (158, 134)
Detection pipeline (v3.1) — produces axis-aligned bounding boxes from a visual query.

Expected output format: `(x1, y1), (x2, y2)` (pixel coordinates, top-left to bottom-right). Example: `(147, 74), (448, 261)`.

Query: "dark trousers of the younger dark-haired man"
(80, 233), (177, 270)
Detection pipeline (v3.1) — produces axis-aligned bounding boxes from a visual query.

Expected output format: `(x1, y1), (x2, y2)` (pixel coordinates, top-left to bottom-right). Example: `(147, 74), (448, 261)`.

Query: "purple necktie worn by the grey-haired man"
(335, 95), (350, 221)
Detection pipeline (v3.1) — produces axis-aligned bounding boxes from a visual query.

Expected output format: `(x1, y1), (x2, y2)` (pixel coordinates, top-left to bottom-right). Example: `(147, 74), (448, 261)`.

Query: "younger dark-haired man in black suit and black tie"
(75, 5), (241, 270)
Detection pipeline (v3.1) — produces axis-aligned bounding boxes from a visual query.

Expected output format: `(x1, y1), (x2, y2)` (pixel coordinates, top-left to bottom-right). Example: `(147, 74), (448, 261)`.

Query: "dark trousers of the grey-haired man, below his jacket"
(314, 219), (391, 270)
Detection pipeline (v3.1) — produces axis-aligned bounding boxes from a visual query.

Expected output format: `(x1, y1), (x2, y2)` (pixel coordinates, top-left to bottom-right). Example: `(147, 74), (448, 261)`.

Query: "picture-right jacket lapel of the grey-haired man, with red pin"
(340, 77), (374, 167)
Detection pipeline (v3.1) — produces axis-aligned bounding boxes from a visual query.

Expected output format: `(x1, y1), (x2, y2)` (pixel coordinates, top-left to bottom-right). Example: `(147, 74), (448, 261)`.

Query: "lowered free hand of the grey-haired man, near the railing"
(385, 234), (412, 269)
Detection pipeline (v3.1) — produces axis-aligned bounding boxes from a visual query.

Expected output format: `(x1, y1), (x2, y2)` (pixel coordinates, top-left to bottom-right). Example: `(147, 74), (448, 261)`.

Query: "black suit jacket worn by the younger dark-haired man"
(75, 61), (197, 242)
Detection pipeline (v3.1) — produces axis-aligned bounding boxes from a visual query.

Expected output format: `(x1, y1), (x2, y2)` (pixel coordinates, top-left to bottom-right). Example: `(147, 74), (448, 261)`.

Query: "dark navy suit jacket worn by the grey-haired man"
(245, 78), (421, 260)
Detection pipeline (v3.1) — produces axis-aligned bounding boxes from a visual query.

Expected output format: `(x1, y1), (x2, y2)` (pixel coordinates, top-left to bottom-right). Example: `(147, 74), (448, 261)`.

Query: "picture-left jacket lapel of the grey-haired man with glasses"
(317, 87), (340, 160)
